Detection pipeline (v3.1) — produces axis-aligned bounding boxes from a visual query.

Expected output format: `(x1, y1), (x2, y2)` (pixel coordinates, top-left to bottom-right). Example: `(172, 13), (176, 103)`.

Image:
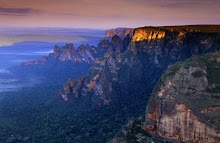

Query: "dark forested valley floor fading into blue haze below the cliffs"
(0, 61), (148, 143)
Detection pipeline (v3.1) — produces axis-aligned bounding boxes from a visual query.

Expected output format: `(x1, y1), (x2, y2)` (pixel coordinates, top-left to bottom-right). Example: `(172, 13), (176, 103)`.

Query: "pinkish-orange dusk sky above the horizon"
(0, 0), (220, 29)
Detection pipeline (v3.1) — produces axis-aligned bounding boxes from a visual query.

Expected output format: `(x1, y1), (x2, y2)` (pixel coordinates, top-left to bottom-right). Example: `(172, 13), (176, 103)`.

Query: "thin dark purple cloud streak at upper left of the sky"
(0, 7), (40, 15)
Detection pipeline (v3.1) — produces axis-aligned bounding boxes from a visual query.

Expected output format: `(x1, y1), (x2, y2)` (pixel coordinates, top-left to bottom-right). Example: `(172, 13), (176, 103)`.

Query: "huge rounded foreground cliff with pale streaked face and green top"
(145, 53), (220, 143)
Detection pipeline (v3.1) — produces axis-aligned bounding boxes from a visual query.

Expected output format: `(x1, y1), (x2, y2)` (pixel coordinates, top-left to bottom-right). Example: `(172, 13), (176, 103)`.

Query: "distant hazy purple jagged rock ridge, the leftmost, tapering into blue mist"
(22, 40), (108, 66)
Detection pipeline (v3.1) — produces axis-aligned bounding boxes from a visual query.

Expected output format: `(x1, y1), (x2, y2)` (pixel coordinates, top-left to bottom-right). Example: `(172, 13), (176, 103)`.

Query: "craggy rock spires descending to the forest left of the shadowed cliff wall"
(60, 35), (131, 101)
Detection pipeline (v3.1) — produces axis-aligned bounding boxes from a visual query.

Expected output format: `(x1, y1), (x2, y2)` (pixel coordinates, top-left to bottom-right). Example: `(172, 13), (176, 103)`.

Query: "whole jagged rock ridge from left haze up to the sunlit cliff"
(21, 35), (131, 66)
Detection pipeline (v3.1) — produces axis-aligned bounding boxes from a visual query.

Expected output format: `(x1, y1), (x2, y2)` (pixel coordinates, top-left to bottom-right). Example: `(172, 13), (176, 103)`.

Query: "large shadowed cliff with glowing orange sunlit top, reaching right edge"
(61, 27), (220, 105)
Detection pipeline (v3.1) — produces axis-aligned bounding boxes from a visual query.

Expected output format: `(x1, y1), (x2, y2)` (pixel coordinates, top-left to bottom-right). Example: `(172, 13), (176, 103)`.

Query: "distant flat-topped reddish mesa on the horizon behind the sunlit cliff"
(105, 28), (133, 38)
